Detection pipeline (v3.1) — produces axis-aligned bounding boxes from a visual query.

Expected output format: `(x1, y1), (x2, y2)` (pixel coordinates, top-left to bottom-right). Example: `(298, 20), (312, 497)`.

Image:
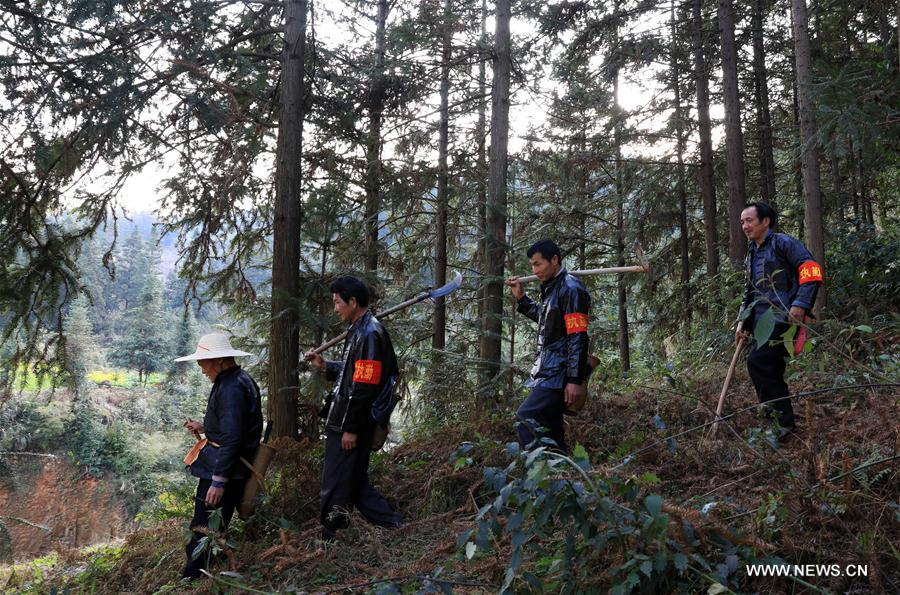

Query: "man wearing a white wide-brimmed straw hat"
(175, 333), (263, 579)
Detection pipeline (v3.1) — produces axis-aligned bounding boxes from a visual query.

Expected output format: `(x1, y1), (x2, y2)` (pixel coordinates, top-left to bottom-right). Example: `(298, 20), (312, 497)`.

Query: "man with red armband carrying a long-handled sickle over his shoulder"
(304, 277), (401, 540)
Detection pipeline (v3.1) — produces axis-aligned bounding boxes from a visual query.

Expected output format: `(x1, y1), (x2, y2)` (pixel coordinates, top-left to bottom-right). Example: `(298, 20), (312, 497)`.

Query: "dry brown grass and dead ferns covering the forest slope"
(10, 366), (900, 593)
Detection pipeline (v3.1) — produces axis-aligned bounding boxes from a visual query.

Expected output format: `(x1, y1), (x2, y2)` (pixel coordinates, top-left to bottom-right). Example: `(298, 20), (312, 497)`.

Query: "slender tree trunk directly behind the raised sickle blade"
(431, 0), (453, 354)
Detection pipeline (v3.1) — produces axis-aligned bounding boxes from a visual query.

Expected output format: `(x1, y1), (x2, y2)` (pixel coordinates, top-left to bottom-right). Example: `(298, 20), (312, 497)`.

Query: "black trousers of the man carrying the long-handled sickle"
(319, 426), (402, 535)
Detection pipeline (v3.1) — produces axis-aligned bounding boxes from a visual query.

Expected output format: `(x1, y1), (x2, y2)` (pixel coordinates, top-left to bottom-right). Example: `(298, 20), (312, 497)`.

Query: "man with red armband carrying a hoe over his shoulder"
(506, 240), (591, 452)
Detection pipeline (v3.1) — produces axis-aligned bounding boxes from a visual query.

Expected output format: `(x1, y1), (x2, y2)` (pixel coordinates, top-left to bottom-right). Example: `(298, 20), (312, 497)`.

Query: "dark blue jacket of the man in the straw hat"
(191, 366), (263, 479)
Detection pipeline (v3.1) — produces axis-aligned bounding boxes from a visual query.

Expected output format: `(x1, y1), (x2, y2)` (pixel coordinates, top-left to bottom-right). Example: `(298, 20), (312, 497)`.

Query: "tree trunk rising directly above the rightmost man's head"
(750, 0), (777, 207)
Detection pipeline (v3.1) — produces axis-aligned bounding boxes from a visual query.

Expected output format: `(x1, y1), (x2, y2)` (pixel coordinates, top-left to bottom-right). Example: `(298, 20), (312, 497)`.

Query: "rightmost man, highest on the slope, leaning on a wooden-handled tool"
(735, 203), (822, 438)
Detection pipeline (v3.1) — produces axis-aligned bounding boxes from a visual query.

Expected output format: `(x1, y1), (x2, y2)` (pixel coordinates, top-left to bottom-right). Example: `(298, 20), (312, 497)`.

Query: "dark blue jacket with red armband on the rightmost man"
(739, 231), (823, 329)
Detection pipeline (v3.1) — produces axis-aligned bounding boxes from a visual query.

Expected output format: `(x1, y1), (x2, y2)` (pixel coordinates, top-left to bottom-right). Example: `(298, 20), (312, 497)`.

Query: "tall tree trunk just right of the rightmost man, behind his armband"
(792, 0), (826, 311)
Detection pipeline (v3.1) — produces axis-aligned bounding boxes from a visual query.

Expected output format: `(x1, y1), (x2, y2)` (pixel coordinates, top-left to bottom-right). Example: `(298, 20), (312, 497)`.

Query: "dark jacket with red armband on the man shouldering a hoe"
(517, 269), (591, 389)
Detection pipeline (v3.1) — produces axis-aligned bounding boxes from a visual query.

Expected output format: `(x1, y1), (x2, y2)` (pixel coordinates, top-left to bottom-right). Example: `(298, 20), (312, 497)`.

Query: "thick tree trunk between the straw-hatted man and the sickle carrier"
(268, 0), (307, 438)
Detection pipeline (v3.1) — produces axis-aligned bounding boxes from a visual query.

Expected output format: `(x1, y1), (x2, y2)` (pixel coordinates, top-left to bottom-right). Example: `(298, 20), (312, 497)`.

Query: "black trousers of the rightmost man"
(747, 324), (796, 428)
